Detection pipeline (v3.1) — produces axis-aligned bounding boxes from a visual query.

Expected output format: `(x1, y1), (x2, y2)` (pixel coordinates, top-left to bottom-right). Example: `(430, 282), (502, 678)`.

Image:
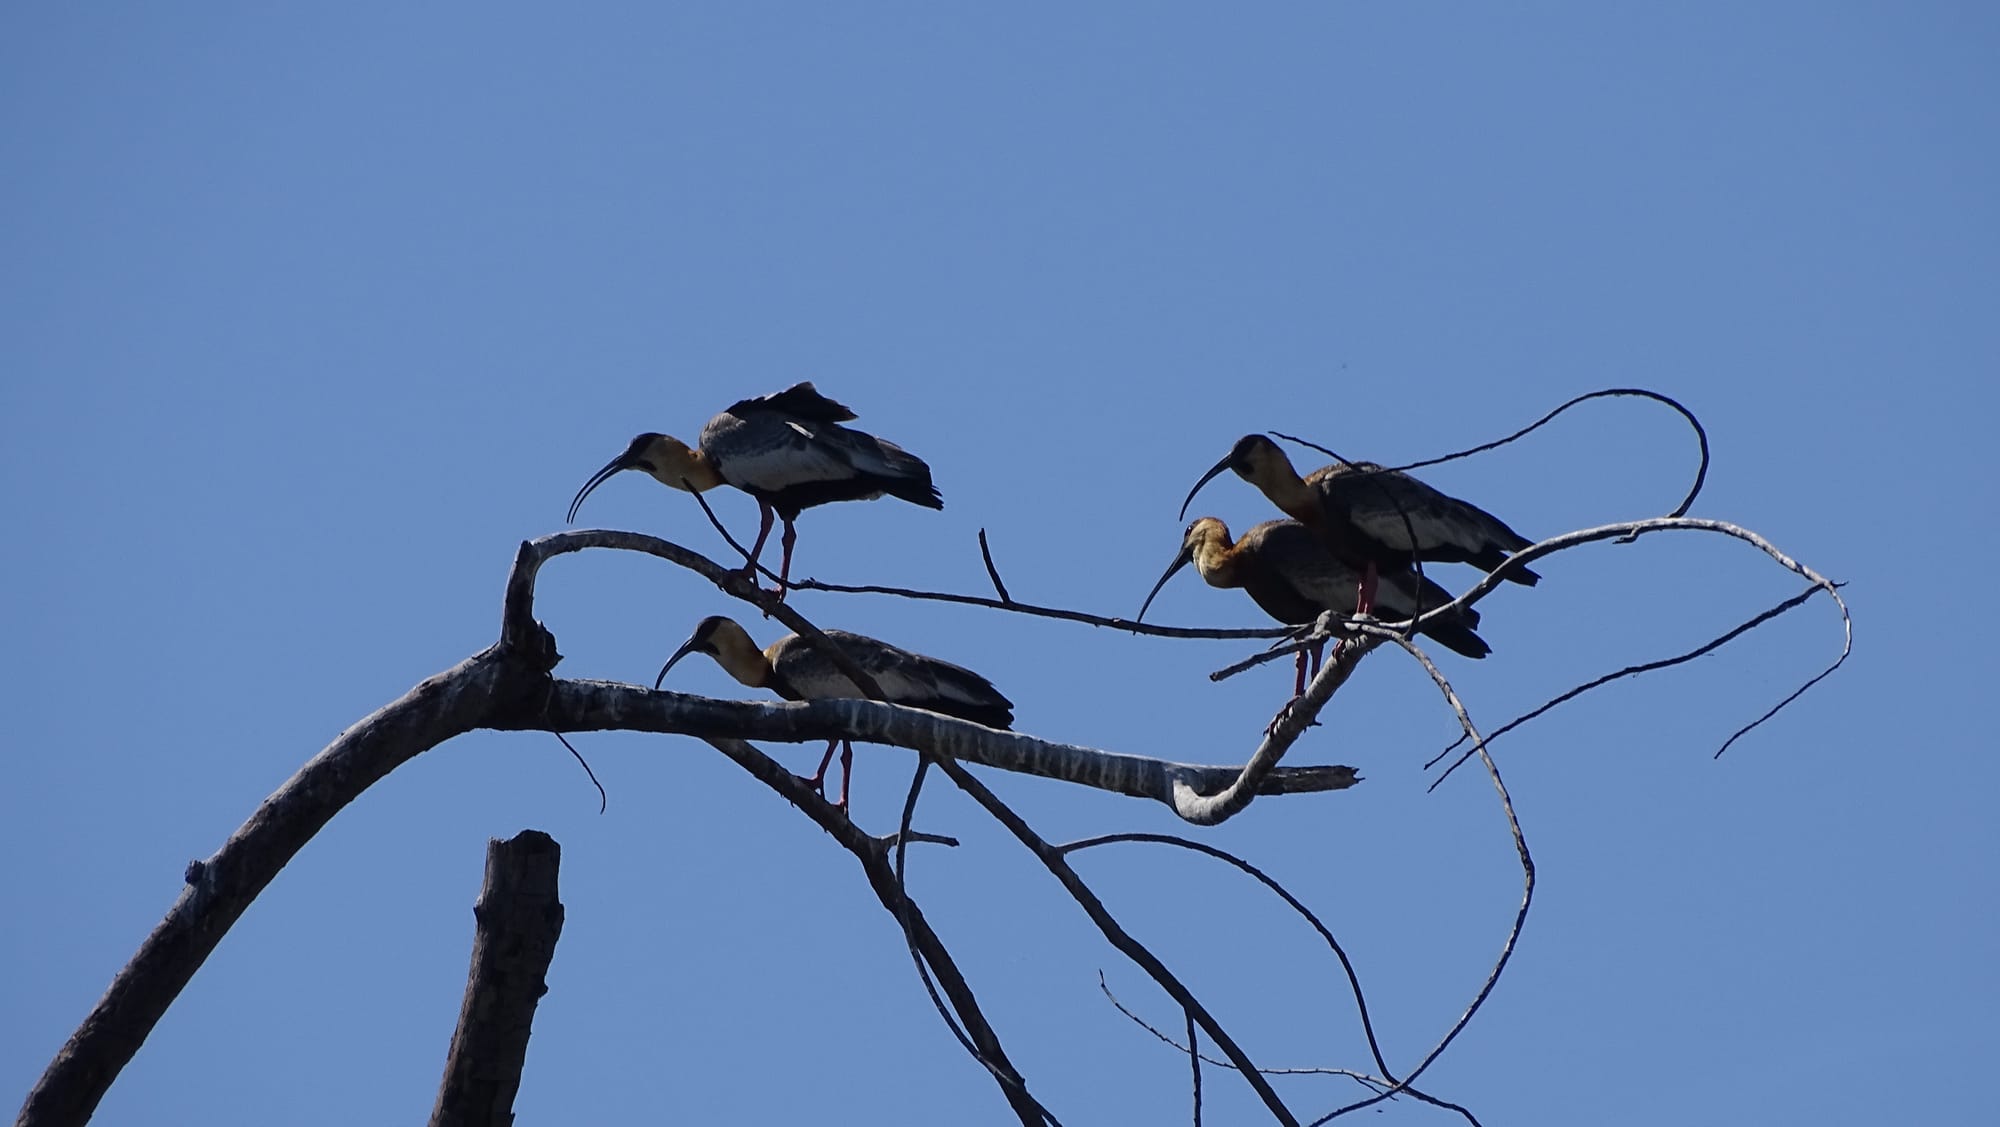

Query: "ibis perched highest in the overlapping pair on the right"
(1180, 434), (1542, 613)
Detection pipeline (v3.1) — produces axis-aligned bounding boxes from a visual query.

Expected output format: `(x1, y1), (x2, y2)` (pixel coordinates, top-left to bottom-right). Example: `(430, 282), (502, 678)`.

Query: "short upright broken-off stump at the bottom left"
(430, 829), (562, 1127)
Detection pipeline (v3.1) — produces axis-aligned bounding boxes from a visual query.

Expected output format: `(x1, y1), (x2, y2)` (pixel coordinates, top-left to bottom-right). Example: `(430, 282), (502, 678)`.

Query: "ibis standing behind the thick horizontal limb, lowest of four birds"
(652, 613), (1014, 809)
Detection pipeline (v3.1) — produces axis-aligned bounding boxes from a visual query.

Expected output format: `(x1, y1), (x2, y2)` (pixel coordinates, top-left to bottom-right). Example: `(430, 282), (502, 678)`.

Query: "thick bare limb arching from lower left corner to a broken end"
(27, 532), (1356, 1127)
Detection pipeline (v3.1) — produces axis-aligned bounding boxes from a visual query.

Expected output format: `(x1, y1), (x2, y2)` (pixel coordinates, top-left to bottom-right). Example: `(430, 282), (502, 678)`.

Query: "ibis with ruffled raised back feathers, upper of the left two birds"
(568, 380), (944, 597)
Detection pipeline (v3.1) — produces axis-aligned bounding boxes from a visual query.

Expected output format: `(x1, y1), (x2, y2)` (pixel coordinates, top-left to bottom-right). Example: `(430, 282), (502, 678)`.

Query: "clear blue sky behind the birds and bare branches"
(0, 2), (2000, 1125)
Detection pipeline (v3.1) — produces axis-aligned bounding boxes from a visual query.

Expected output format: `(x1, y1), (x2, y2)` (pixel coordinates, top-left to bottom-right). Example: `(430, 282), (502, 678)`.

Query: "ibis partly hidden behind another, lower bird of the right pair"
(1134, 518), (1492, 695)
